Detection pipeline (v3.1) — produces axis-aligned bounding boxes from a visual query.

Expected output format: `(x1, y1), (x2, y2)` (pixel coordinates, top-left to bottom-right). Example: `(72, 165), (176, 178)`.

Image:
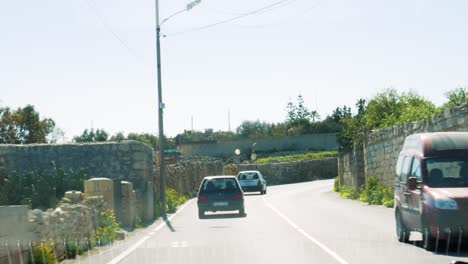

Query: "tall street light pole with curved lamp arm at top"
(155, 0), (201, 216)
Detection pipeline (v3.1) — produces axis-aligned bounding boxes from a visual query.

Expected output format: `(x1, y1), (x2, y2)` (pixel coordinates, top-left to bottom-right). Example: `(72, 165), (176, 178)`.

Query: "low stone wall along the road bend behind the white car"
(224, 158), (338, 185)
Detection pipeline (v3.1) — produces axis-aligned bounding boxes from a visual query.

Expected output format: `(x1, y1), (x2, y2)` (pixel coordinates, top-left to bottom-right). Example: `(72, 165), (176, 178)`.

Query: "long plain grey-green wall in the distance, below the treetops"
(180, 133), (338, 158)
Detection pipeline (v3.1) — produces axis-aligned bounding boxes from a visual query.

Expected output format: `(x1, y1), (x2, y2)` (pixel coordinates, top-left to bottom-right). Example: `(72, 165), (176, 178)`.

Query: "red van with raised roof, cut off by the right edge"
(394, 132), (468, 250)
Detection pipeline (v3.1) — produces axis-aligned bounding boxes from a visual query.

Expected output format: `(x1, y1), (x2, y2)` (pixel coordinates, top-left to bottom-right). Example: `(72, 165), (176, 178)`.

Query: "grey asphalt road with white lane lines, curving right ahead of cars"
(79, 180), (468, 264)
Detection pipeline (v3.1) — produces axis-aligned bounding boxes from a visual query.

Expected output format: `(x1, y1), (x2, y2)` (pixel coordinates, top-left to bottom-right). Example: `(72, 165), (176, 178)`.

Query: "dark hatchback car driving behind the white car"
(197, 176), (245, 218)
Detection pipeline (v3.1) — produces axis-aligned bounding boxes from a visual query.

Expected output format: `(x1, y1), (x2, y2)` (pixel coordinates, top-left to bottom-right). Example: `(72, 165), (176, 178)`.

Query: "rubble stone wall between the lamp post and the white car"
(154, 157), (224, 193)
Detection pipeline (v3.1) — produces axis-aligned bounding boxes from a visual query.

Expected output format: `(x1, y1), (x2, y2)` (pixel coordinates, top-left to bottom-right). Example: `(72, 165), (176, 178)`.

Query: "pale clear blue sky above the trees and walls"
(0, 0), (468, 138)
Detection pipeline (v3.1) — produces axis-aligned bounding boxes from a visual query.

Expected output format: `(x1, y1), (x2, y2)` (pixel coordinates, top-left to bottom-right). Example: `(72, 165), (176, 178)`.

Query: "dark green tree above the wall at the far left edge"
(0, 105), (55, 144)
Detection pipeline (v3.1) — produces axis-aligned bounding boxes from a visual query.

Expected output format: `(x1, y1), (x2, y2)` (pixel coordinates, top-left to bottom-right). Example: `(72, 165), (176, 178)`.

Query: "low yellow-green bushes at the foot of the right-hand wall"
(333, 176), (394, 208)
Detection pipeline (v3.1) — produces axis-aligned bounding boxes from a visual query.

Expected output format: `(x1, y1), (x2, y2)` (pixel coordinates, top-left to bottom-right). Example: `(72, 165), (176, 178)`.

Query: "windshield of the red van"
(426, 157), (468, 188)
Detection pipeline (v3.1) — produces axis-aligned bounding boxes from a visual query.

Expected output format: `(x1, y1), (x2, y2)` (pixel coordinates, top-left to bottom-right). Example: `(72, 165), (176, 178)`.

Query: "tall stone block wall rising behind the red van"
(338, 104), (468, 190)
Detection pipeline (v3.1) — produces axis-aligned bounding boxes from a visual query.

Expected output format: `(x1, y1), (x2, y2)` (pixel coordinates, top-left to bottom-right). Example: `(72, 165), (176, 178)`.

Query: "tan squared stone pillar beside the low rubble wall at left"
(84, 178), (114, 210)
